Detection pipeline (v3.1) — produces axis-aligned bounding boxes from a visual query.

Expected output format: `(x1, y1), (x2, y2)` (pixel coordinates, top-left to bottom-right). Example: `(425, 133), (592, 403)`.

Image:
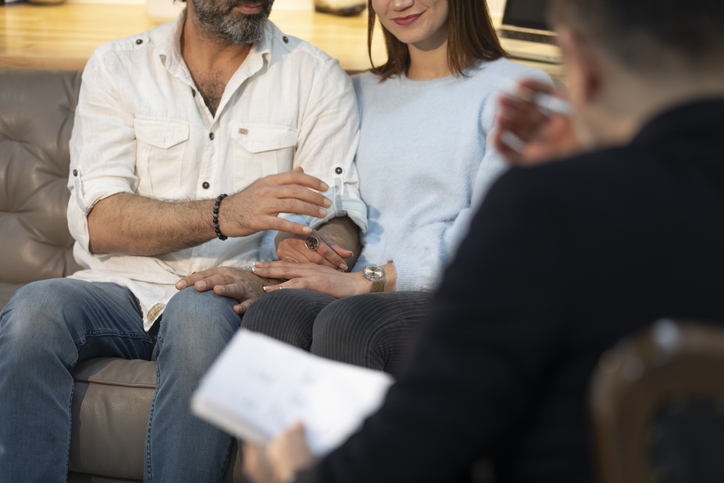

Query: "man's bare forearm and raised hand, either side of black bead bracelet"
(88, 168), (332, 256)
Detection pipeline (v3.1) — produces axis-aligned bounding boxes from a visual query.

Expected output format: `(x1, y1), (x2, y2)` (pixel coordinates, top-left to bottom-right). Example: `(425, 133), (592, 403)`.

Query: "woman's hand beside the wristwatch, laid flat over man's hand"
(252, 260), (372, 298)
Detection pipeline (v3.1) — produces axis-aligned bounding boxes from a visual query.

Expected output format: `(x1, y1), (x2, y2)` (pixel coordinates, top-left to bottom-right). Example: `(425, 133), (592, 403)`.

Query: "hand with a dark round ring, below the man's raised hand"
(276, 230), (354, 272)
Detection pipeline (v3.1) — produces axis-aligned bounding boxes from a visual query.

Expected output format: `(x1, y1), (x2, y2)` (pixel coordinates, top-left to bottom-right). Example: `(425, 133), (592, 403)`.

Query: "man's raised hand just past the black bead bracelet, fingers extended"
(219, 168), (332, 237)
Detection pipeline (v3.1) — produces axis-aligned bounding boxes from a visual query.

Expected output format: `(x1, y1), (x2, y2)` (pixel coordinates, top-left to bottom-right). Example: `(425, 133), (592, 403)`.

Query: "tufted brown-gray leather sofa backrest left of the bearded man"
(0, 67), (81, 286)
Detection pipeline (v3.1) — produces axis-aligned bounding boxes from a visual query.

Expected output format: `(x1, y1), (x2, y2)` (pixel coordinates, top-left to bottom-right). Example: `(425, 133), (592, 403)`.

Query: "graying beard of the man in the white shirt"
(191, 0), (274, 44)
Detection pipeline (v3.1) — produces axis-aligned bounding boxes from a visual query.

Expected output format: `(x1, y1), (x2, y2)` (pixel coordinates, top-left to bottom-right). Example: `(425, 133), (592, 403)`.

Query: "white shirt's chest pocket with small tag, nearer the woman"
(231, 123), (297, 191)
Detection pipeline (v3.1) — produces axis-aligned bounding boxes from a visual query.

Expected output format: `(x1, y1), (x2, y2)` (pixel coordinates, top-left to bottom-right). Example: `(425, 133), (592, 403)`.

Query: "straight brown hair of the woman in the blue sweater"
(367, 0), (506, 80)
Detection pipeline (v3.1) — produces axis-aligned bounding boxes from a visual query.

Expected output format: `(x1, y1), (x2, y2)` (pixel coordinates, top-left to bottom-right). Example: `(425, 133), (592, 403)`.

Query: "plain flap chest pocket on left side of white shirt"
(133, 117), (189, 197)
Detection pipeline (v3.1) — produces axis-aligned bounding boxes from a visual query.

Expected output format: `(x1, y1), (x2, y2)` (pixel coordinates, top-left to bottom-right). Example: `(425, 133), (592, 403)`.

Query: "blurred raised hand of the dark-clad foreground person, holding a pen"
(493, 81), (581, 166)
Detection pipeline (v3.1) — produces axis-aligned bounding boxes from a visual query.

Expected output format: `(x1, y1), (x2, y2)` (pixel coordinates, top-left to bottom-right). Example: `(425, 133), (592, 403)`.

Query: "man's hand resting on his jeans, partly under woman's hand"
(176, 267), (281, 315)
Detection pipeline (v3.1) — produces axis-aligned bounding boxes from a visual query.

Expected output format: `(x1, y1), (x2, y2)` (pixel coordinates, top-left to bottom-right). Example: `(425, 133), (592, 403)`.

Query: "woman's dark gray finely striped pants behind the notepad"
(241, 289), (432, 372)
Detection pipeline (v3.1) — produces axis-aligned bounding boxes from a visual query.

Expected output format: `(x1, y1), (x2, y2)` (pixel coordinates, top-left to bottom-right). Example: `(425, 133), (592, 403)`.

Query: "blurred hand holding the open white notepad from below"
(242, 423), (318, 483)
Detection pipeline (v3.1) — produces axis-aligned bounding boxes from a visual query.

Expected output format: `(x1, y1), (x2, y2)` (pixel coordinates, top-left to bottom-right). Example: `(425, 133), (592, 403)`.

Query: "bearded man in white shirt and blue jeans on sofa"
(0, 0), (366, 482)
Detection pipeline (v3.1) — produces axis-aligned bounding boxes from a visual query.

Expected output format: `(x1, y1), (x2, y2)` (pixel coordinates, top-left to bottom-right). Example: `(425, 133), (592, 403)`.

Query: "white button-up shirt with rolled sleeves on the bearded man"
(68, 11), (367, 330)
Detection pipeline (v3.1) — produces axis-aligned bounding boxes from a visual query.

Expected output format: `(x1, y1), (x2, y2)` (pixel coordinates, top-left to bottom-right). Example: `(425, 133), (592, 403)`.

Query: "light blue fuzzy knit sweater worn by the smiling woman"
(353, 59), (550, 290)
